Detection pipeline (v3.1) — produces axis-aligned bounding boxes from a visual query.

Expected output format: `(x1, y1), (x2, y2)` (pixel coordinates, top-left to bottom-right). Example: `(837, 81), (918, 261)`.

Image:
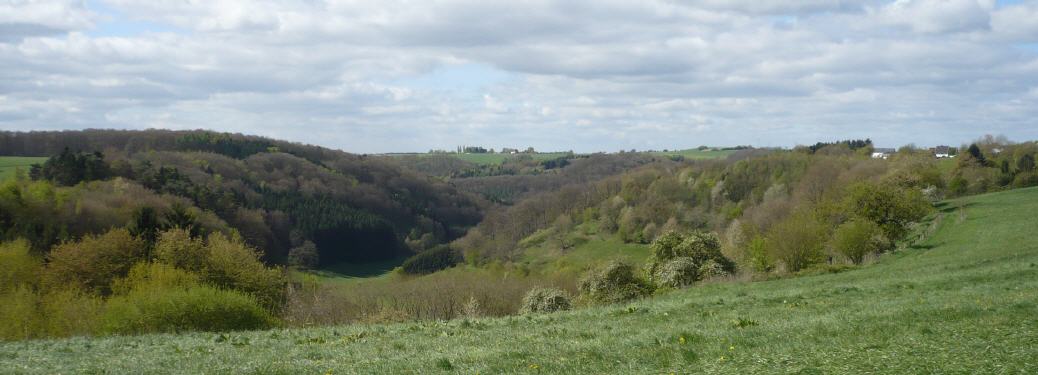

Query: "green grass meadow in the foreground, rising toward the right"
(0, 188), (1038, 374)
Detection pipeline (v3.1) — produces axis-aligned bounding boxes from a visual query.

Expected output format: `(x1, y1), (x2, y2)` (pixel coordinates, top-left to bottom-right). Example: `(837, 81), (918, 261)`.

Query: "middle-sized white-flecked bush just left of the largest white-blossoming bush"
(577, 262), (652, 303)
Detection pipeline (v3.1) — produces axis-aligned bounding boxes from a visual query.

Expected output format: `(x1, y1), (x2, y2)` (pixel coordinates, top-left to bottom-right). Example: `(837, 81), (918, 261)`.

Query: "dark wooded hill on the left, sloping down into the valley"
(0, 130), (483, 266)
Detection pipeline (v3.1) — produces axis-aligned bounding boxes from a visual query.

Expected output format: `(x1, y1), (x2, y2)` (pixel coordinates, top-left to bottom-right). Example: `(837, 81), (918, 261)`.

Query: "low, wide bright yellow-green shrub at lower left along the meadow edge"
(102, 286), (276, 334)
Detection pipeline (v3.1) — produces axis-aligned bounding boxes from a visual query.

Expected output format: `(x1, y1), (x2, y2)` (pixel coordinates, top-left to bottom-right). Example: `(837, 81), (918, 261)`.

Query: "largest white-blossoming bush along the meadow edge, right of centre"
(647, 227), (735, 288)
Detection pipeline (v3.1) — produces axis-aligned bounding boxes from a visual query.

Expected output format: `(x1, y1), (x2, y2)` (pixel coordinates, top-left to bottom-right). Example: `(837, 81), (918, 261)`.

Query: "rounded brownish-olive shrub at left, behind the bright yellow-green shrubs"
(44, 230), (144, 295)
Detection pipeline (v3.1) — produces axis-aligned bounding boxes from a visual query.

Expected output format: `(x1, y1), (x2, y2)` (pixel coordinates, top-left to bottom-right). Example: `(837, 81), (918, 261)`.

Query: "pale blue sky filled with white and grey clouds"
(0, 0), (1038, 153)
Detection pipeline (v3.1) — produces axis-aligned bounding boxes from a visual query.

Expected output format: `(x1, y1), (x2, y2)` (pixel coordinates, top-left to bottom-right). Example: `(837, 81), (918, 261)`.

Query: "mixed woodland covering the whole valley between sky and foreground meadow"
(0, 130), (1038, 340)
